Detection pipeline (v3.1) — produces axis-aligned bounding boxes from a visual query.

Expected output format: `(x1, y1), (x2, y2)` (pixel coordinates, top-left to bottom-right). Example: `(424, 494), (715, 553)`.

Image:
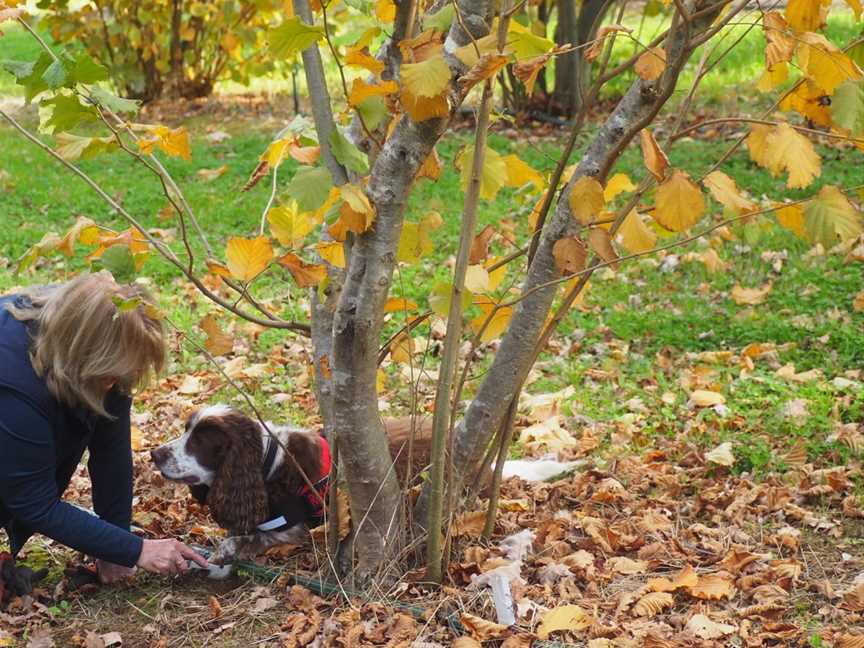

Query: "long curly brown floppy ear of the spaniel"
(207, 413), (267, 535)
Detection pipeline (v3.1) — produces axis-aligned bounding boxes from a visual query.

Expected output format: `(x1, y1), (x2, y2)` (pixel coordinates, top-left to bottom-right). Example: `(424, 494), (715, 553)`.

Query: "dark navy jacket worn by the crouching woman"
(0, 295), (142, 567)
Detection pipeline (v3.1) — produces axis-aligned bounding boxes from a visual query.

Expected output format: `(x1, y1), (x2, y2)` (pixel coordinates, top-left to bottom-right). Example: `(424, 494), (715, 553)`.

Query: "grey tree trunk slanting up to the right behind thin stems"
(415, 0), (722, 520)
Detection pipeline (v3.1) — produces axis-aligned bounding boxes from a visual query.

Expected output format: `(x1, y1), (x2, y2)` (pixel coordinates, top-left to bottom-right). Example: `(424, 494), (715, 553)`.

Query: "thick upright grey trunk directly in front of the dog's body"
(295, 0), (491, 582)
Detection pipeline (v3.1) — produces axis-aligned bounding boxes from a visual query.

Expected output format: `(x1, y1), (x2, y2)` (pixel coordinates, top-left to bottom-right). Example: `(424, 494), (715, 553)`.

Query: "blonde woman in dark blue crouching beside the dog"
(0, 273), (207, 582)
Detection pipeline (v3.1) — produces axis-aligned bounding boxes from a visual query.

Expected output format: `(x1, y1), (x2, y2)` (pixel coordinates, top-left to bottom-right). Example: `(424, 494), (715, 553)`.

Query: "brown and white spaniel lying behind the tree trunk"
(150, 405), (431, 565)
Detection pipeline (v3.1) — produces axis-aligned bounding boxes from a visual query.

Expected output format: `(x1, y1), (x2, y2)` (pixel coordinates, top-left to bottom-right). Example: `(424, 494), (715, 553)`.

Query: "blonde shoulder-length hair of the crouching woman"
(8, 271), (165, 416)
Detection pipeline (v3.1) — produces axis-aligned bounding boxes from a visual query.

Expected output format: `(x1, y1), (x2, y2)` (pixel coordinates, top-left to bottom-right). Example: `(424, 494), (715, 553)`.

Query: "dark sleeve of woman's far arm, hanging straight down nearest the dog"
(87, 392), (132, 531)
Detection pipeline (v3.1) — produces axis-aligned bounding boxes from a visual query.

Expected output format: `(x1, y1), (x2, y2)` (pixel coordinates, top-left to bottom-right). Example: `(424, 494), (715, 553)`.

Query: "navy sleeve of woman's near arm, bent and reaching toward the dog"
(0, 389), (142, 567)
